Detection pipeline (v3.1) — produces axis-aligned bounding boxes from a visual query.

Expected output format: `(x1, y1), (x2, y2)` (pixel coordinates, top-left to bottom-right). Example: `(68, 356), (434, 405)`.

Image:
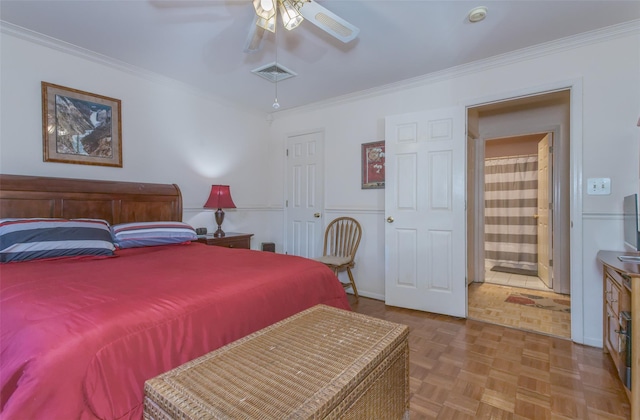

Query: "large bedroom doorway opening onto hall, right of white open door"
(467, 89), (571, 338)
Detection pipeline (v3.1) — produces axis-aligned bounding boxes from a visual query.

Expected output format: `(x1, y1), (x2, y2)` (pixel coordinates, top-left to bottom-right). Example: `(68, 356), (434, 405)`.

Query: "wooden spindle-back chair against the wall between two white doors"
(316, 217), (362, 299)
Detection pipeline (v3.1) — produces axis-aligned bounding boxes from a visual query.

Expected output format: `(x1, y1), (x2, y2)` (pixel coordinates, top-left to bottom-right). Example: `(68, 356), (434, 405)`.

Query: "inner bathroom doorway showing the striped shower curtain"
(484, 133), (553, 291)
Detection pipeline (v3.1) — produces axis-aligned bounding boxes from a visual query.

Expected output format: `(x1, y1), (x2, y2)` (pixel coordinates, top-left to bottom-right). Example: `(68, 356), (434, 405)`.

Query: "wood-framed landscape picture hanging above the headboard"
(42, 82), (122, 168)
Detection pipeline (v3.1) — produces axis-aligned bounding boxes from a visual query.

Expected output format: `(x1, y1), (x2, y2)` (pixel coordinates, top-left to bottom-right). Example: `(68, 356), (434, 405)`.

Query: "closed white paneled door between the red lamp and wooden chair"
(286, 132), (324, 258)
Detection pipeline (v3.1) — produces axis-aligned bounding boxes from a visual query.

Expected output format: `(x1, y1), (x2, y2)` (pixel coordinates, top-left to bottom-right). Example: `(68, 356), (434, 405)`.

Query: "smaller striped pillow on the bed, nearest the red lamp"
(111, 222), (198, 249)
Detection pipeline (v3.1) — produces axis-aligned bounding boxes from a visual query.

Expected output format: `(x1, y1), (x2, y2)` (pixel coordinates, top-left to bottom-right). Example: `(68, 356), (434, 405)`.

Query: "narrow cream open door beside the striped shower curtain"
(536, 134), (553, 289)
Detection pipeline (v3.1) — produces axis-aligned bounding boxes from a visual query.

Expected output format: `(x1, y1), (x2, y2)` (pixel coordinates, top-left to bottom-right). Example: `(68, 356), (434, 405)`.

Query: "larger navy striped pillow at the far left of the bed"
(0, 218), (115, 262)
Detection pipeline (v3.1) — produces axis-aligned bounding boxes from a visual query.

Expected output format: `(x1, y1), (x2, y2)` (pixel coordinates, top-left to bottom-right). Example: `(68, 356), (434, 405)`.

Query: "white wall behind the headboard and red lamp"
(0, 27), (282, 248)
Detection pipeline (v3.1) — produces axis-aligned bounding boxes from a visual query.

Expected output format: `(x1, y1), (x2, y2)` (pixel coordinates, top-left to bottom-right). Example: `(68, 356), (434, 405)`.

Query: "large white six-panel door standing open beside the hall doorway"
(385, 107), (467, 317)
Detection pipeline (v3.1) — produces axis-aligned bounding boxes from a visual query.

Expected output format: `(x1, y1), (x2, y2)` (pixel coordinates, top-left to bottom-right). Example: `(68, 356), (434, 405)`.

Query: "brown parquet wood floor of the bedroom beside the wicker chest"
(349, 295), (631, 420)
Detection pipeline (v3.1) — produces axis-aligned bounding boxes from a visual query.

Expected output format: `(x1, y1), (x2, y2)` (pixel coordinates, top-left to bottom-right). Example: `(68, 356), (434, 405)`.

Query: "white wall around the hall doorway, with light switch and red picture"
(272, 22), (640, 346)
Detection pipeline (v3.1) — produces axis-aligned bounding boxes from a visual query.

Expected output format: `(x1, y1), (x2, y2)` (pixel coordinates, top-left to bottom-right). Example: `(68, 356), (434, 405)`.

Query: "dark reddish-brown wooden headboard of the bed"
(0, 174), (182, 224)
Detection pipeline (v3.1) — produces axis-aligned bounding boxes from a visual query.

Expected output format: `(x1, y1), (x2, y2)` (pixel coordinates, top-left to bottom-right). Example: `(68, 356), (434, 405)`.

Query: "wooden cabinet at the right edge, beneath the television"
(598, 251), (640, 419)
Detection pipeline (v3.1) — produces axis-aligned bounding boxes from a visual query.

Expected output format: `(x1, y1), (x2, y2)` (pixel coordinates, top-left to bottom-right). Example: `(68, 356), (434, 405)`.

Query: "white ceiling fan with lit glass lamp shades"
(244, 0), (360, 53)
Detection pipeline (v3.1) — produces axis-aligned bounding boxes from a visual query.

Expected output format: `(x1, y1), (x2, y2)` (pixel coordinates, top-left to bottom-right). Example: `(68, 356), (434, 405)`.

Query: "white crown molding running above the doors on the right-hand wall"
(271, 19), (640, 120)
